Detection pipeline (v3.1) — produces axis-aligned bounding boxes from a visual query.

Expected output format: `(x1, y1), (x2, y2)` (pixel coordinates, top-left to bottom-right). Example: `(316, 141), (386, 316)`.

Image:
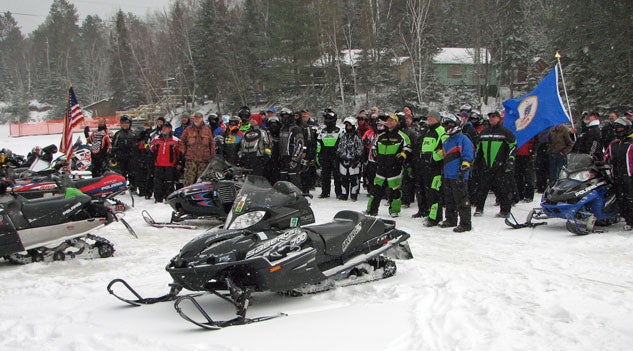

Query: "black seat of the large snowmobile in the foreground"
(303, 211), (365, 256)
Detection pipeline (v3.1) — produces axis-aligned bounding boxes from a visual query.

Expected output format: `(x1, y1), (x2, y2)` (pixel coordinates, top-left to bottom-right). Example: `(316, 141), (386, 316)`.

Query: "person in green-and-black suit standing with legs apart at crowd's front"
(367, 114), (411, 217)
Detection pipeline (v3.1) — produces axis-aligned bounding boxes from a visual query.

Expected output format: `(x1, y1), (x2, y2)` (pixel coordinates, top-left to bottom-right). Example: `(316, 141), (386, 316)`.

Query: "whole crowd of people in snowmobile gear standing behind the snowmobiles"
(85, 104), (633, 232)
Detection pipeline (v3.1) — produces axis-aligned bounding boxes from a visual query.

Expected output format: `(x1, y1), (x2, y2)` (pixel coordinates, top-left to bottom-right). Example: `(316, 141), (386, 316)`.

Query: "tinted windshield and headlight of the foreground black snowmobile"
(224, 175), (307, 229)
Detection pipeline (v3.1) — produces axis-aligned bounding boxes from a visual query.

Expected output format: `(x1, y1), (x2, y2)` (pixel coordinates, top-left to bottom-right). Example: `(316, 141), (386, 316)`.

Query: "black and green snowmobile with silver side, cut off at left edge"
(0, 182), (136, 264)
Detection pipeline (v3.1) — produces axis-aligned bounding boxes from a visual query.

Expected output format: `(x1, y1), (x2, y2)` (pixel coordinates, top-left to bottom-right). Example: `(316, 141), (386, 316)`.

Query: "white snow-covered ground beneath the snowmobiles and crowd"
(0, 126), (633, 351)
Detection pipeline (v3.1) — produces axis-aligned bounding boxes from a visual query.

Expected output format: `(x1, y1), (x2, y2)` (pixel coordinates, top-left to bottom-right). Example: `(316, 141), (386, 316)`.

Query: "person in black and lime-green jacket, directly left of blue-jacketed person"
(416, 110), (448, 227)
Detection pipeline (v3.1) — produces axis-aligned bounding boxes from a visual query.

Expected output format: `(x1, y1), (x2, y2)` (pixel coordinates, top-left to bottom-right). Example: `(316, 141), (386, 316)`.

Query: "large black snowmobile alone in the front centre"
(107, 176), (413, 329)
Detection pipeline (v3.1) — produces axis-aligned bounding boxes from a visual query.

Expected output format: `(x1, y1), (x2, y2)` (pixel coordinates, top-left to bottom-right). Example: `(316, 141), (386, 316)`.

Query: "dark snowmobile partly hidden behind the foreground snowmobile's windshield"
(165, 156), (247, 223)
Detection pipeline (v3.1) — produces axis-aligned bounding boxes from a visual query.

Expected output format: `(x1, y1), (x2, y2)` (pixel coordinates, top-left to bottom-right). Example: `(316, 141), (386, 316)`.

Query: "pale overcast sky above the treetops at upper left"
(0, 0), (171, 34)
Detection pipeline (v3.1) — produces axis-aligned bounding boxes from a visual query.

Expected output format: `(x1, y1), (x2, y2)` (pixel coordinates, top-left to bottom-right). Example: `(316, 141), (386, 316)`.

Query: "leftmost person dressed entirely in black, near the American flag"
(112, 115), (138, 187)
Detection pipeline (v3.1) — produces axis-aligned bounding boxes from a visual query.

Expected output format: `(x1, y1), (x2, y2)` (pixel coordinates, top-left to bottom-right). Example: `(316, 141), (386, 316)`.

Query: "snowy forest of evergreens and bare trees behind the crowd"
(0, 0), (633, 122)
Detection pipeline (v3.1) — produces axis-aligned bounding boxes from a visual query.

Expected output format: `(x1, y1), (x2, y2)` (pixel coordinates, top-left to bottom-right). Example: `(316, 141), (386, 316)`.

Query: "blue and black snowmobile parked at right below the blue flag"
(505, 154), (619, 235)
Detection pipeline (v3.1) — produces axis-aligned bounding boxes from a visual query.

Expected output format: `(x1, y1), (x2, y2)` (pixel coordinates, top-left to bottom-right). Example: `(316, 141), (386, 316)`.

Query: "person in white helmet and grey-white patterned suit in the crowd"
(336, 117), (363, 201)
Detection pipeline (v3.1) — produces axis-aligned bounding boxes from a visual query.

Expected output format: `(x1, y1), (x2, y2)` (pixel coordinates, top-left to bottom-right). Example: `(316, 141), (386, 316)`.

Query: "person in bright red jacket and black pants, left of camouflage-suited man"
(150, 122), (179, 202)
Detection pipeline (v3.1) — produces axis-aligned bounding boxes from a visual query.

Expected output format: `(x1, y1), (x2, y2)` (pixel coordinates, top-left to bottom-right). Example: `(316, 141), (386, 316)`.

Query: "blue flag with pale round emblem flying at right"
(503, 66), (570, 147)
